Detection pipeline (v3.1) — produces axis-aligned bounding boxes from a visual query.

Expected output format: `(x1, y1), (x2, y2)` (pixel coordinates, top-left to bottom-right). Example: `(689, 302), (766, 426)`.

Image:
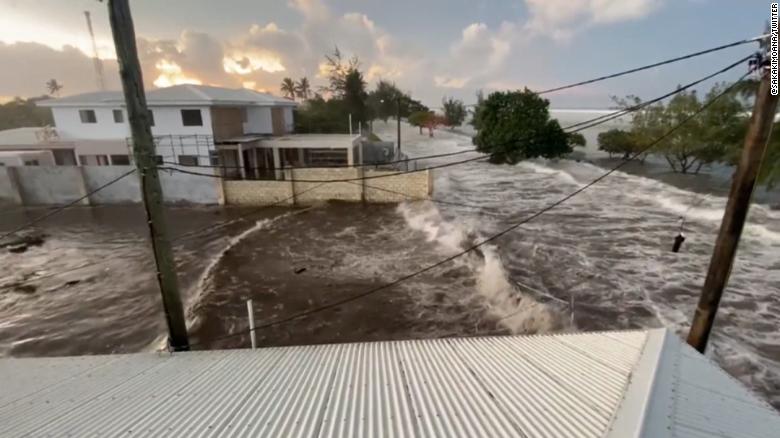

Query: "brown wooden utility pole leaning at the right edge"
(688, 56), (778, 353)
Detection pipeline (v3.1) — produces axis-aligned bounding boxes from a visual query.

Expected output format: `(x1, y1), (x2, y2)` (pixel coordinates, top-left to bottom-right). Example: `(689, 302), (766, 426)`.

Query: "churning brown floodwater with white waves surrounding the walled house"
(0, 120), (780, 406)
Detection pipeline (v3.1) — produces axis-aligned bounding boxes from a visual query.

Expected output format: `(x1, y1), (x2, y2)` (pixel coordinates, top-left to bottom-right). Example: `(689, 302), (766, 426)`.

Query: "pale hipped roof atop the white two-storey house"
(37, 84), (297, 107)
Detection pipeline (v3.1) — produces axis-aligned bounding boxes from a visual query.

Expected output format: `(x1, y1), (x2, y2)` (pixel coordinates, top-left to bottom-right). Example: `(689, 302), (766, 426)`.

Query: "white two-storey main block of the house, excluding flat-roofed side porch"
(38, 85), (296, 171)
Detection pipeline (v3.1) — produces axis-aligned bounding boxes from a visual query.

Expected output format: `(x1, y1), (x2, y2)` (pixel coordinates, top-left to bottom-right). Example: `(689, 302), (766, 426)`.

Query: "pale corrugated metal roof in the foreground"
(0, 330), (780, 437)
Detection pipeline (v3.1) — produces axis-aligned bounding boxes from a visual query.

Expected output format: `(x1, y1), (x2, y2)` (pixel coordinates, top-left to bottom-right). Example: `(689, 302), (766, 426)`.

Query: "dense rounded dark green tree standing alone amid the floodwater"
(473, 88), (572, 164)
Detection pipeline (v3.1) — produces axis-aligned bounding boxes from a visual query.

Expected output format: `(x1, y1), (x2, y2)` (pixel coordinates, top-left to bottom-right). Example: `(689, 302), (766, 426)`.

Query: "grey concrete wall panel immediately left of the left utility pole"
(81, 166), (141, 204)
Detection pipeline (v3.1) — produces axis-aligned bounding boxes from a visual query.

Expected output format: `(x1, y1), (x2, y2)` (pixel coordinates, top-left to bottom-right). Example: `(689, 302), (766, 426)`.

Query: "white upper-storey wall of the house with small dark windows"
(52, 106), (213, 140)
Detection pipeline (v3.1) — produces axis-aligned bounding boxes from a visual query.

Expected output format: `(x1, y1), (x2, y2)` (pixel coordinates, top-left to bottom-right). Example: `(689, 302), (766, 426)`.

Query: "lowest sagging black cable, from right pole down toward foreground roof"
(187, 72), (750, 345)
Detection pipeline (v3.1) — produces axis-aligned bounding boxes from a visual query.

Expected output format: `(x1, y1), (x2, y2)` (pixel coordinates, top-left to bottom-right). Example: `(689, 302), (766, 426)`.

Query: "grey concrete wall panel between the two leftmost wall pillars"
(9, 166), (89, 205)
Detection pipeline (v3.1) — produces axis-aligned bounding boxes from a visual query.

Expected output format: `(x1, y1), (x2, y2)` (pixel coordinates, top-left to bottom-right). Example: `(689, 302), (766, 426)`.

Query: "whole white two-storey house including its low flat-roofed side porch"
(33, 85), (361, 177)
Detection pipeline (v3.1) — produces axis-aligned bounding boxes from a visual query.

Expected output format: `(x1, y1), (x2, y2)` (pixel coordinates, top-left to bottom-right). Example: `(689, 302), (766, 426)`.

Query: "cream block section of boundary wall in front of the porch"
(223, 168), (433, 206)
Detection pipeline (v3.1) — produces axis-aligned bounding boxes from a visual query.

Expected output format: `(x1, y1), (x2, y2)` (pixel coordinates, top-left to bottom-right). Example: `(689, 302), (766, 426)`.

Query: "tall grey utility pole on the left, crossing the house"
(108, 0), (190, 351)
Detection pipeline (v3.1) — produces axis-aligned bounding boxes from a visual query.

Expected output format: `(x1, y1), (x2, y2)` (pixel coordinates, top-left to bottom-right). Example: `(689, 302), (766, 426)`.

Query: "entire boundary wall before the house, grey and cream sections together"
(0, 166), (433, 206)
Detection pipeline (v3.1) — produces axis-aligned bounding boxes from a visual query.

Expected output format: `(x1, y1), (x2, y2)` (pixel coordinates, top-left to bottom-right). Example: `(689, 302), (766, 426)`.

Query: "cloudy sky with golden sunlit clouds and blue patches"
(0, 0), (770, 108)
